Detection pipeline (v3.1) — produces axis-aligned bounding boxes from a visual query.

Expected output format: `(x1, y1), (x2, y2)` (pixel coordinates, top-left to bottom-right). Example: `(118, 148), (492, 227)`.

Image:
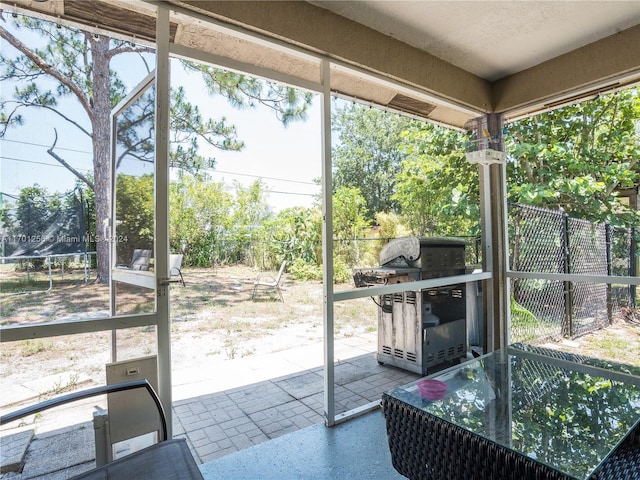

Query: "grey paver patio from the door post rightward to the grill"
(173, 333), (418, 463)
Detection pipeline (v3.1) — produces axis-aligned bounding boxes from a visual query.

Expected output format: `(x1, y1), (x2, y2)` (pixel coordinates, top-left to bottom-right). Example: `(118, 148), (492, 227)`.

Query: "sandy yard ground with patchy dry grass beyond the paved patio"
(0, 266), (640, 407)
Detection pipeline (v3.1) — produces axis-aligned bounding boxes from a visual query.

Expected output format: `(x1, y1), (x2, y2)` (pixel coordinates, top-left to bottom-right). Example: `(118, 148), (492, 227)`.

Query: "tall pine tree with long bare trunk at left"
(0, 14), (312, 282)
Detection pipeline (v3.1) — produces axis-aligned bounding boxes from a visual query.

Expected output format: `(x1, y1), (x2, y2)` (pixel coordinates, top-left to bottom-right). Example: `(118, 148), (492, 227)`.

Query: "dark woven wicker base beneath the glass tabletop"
(382, 394), (640, 480)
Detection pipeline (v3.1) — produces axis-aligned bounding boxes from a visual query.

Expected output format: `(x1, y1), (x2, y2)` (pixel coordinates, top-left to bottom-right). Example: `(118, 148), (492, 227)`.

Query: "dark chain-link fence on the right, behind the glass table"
(508, 204), (638, 342)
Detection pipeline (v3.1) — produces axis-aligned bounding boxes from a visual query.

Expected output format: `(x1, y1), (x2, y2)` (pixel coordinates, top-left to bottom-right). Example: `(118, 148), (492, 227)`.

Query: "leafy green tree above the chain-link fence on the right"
(507, 87), (640, 225)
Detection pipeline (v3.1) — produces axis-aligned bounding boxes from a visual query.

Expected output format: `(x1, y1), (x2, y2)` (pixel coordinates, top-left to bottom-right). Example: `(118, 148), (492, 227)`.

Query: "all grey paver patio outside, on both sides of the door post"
(0, 333), (418, 480)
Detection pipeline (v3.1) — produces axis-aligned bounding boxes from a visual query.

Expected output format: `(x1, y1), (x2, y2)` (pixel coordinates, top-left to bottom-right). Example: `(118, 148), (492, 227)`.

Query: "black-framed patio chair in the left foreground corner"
(0, 379), (203, 480)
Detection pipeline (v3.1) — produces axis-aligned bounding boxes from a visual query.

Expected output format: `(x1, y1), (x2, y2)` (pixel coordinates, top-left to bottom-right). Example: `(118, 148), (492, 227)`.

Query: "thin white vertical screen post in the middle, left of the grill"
(320, 59), (336, 427)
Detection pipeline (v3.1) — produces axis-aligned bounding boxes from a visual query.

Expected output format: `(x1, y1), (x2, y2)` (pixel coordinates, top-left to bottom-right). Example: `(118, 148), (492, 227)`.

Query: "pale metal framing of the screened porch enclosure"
(0, 2), (640, 435)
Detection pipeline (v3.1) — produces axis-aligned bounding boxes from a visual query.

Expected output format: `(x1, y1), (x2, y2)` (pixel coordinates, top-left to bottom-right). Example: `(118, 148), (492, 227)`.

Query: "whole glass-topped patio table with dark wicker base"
(382, 345), (640, 480)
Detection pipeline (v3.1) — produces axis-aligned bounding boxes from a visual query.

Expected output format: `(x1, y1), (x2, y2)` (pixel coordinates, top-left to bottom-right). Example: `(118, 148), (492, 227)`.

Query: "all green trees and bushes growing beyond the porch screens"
(0, 17), (640, 296)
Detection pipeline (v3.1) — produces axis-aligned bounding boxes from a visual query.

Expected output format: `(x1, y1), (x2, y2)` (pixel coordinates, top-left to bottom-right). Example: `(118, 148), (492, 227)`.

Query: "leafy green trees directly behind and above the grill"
(333, 104), (479, 235)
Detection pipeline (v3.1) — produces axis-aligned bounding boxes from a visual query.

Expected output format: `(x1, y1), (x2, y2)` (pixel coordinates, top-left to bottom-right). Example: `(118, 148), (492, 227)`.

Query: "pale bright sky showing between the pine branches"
(0, 22), (321, 211)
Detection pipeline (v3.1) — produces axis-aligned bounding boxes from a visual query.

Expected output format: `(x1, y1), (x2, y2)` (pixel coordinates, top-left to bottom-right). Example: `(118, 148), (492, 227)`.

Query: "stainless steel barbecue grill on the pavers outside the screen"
(353, 237), (467, 375)
